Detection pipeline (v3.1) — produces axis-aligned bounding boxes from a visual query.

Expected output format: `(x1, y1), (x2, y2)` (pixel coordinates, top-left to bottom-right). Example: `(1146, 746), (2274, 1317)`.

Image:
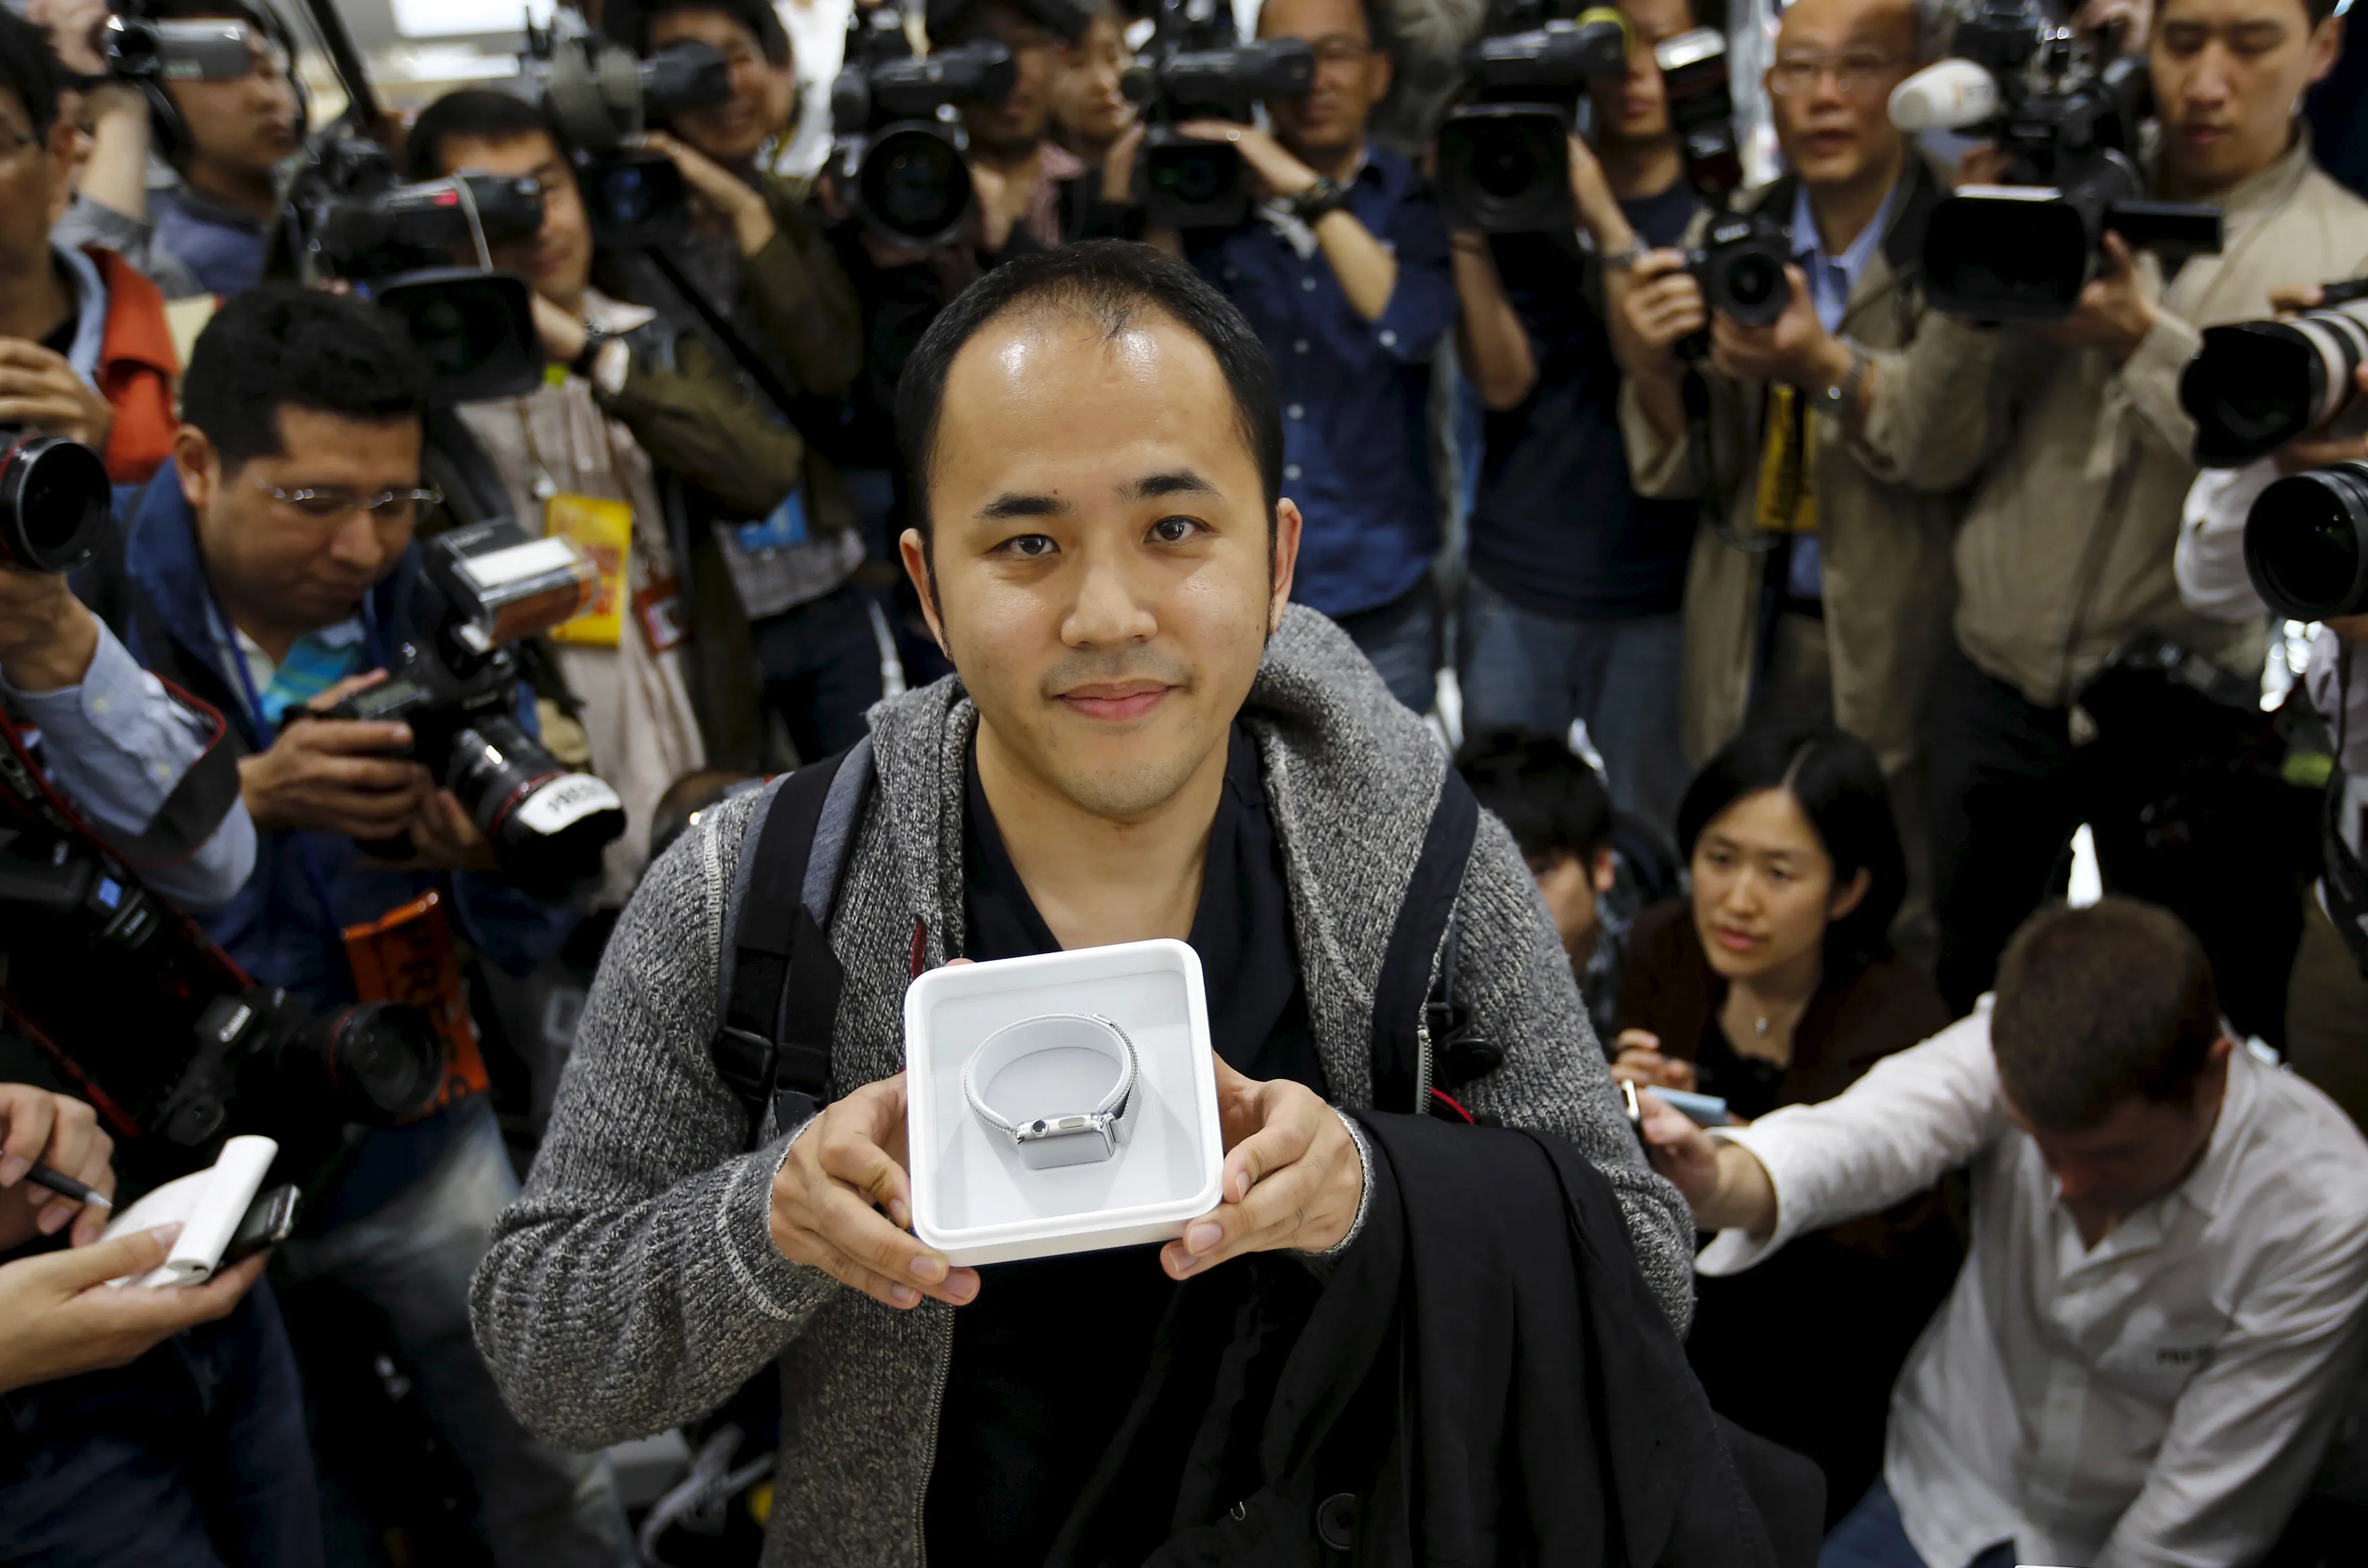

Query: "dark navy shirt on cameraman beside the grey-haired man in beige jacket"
(1471, 183), (1700, 620)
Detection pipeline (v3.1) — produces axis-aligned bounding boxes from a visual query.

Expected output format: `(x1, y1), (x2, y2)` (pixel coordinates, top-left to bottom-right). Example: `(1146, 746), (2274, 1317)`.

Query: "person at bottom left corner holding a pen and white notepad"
(0, 1082), (322, 1568)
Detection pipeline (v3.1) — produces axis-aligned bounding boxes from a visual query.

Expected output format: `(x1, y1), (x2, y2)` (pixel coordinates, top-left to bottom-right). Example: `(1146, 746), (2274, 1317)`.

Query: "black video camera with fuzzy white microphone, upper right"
(1890, 0), (2221, 322)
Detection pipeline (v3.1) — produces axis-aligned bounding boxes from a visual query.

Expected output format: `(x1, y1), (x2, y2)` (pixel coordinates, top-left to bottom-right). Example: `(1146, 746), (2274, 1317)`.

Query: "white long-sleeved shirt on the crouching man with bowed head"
(1695, 997), (2368, 1568)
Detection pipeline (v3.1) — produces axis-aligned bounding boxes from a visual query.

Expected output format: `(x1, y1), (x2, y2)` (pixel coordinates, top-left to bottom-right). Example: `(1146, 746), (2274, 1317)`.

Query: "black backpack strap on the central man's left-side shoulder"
(708, 737), (871, 1149)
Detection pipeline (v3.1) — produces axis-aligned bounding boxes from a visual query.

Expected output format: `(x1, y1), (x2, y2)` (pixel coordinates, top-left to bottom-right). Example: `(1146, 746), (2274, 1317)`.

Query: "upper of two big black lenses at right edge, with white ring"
(2179, 282), (2368, 469)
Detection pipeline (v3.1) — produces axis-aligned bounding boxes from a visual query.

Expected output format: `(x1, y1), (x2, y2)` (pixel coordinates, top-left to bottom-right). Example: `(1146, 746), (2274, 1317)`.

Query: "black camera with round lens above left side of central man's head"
(832, 5), (1016, 249)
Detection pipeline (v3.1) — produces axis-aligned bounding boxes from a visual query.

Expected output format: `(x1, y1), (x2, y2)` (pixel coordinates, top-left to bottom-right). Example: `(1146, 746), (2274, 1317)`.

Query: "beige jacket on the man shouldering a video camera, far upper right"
(1869, 137), (2368, 708)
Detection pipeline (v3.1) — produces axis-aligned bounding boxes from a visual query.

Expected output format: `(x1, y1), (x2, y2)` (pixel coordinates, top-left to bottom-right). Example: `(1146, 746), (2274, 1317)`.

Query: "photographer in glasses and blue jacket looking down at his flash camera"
(97, 284), (625, 1563)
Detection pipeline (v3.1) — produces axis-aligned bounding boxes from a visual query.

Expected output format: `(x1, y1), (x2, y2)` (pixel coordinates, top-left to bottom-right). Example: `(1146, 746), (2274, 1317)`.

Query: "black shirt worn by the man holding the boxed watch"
(924, 724), (1324, 1563)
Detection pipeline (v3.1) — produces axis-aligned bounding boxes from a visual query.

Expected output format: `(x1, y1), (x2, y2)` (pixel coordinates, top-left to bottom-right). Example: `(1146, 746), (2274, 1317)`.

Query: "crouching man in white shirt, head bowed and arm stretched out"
(1646, 898), (2368, 1568)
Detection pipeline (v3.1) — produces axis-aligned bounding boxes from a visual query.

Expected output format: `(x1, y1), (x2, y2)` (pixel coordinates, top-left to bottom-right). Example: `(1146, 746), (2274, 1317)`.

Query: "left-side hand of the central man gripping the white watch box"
(770, 1073), (978, 1308)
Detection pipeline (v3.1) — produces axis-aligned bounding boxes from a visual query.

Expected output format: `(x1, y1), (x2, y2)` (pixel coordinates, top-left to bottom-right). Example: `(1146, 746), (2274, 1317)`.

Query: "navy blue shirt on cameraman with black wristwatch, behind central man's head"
(1184, 149), (1457, 616)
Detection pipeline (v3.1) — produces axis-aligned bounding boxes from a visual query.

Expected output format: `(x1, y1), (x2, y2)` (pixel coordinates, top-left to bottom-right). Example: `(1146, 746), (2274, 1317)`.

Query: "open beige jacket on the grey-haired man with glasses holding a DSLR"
(1620, 161), (1959, 781)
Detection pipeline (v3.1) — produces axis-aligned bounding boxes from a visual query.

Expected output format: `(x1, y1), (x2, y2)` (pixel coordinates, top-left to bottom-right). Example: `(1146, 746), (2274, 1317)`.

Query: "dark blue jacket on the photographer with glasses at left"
(85, 462), (580, 1005)
